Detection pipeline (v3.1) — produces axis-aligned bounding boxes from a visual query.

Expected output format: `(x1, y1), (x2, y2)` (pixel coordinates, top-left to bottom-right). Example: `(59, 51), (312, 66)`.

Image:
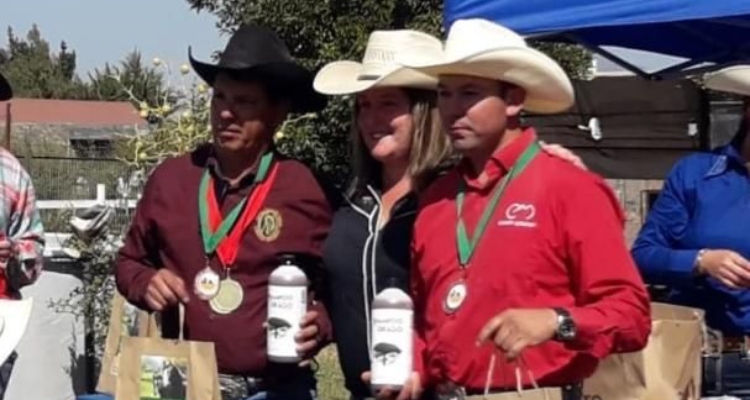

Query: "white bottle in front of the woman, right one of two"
(370, 280), (414, 390)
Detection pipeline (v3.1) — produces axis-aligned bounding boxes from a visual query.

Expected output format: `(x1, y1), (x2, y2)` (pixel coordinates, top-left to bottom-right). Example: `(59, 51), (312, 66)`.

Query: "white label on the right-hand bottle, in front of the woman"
(370, 309), (414, 386)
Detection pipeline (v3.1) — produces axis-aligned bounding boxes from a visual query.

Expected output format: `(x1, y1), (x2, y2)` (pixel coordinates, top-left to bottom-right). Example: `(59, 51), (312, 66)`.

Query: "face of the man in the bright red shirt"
(438, 75), (523, 152)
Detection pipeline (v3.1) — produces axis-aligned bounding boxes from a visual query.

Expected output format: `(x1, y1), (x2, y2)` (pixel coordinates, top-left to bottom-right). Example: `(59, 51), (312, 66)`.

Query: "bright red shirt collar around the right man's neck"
(459, 128), (537, 189)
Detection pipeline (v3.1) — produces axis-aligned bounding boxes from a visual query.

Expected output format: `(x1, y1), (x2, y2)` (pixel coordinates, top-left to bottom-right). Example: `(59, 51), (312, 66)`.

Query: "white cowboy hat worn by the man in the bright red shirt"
(404, 19), (575, 113)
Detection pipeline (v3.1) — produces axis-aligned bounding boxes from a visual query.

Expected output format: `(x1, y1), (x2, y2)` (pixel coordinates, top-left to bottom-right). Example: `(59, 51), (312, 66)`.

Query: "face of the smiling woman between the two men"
(356, 87), (414, 163)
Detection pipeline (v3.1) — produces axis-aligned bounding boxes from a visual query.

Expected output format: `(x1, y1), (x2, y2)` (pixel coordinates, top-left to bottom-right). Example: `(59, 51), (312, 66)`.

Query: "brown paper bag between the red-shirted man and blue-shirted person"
(583, 303), (704, 400)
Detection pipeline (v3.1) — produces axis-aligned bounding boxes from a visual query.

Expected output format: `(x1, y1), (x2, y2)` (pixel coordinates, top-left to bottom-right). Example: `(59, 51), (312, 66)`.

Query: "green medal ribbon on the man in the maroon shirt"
(198, 152), (273, 255)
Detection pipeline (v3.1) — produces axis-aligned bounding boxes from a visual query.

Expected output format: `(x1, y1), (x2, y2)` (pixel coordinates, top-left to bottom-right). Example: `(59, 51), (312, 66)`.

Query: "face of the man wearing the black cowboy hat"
(211, 74), (288, 151)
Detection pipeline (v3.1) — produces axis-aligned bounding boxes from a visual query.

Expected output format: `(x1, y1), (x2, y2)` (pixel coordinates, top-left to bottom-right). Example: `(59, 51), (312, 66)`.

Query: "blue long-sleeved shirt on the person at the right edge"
(632, 145), (750, 335)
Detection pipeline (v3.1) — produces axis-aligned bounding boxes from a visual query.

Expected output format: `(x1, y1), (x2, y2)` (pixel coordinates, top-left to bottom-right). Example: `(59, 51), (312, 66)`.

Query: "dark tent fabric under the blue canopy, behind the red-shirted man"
(524, 76), (709, 179)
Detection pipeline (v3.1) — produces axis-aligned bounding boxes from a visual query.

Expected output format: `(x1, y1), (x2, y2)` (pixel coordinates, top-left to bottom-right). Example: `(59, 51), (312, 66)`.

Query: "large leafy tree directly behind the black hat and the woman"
(186, 0), (591, 186)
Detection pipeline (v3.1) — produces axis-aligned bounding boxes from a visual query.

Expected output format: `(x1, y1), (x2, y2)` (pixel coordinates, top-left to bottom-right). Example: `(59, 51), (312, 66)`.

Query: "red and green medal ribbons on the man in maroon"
(198, 152), (278, 268)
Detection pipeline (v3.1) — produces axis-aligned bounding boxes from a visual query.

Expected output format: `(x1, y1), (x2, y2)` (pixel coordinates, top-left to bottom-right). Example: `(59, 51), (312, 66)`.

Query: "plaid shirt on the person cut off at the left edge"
(0, 148), (44, 298)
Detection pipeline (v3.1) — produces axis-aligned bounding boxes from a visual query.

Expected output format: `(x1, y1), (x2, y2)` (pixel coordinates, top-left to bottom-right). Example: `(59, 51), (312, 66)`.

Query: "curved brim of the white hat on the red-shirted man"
(407, 47), (575, 114)
